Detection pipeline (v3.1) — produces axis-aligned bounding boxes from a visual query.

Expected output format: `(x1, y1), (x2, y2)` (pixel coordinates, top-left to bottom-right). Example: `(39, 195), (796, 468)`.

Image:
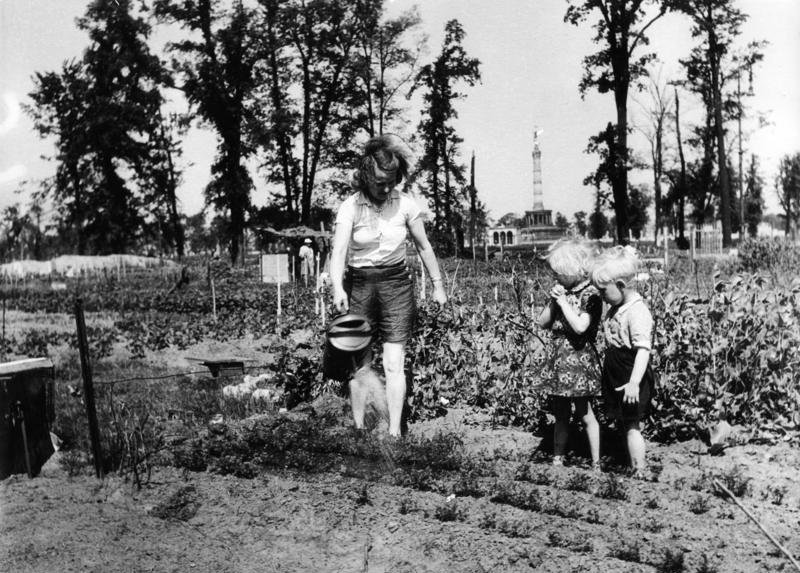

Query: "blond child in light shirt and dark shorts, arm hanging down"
(592, 246), (653, 477)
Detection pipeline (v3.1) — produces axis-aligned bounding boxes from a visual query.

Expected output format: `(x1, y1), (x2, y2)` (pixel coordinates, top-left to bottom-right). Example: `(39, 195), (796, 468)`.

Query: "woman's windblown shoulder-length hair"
(351, 133), (414, 191)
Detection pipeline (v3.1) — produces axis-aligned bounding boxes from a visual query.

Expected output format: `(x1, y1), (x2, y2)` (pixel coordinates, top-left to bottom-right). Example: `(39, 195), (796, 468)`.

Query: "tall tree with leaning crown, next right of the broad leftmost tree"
(153, 0), (260, 262)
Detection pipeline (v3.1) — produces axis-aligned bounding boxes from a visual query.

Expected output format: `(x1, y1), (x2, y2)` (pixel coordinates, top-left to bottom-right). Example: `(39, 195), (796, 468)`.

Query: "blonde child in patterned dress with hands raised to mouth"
(538, 239), (603, 471)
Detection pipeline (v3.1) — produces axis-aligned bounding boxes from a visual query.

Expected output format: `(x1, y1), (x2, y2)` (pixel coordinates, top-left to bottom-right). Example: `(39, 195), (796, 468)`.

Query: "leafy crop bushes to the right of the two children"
(652, 274), (800, 440)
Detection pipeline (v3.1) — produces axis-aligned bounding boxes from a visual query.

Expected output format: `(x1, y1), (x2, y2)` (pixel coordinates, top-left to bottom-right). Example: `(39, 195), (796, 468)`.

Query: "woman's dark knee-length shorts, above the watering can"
(344, 263), (416, 344)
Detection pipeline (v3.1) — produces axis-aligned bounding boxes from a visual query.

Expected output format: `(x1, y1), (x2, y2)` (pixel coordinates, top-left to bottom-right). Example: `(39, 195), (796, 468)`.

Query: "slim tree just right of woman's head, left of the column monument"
(415, 20), (481, 251)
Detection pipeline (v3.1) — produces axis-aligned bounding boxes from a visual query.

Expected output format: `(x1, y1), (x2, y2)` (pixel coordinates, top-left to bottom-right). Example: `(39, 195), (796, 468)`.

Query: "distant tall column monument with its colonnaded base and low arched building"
(485, 131), (563, 246)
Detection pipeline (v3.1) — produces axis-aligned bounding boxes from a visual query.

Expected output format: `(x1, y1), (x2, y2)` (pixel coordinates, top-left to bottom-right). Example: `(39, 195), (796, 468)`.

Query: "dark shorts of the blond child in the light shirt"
(600, 346), (655, 425)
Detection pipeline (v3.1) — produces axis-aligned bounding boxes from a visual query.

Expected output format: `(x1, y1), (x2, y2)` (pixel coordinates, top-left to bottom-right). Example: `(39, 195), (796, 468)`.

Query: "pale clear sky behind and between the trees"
(0, 0), (800, 223)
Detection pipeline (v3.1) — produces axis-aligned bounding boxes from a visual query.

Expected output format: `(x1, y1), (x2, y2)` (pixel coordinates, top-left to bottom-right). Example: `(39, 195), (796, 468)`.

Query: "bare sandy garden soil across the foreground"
(0, 410), (800, 573)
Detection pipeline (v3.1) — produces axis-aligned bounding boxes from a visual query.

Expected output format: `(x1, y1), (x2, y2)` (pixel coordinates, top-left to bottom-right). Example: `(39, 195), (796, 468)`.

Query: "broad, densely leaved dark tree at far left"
(27, 0), (181, 253)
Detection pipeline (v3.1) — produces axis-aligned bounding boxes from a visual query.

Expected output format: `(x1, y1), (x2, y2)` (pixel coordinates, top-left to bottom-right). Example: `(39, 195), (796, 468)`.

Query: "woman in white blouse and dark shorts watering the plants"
(330, 135), (447, 436)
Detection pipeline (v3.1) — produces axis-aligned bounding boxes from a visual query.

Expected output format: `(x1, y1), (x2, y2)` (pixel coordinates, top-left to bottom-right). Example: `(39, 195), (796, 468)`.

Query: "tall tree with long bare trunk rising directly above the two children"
(564, 0), (671, 243)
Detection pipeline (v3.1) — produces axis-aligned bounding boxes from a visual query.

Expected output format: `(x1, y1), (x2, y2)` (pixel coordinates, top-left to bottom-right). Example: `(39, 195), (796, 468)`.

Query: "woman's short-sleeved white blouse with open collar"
(336, 189), (422, 267)
